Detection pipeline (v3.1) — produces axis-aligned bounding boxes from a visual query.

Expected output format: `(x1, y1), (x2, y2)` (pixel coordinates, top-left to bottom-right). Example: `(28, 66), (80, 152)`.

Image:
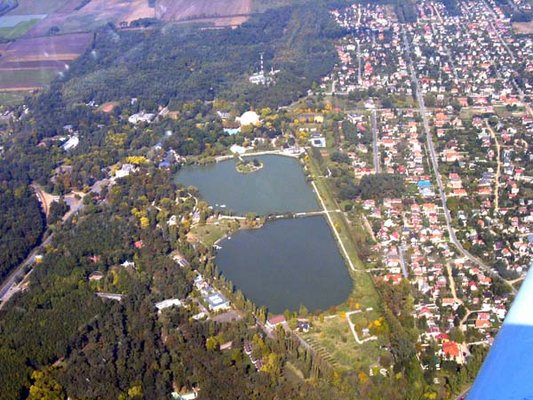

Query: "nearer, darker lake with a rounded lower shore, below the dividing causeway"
(216, 216), (352, 313)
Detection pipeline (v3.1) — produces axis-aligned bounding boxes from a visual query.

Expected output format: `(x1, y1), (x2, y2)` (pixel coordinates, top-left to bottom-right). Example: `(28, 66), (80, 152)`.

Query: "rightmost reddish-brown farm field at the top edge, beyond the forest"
(156, 0), (252, 26)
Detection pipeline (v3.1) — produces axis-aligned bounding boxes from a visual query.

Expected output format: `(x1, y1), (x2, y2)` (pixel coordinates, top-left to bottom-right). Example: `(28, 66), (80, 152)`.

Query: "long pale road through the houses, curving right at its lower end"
(402, 26), (516, 293)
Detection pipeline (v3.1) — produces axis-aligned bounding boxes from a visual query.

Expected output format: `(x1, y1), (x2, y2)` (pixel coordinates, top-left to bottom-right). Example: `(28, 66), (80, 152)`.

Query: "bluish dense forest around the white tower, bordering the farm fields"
(29, 4), (341, 114)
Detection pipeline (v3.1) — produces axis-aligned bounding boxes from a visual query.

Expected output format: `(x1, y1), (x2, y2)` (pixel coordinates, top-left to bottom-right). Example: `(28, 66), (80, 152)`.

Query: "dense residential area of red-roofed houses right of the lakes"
(328, 0), (533, 363)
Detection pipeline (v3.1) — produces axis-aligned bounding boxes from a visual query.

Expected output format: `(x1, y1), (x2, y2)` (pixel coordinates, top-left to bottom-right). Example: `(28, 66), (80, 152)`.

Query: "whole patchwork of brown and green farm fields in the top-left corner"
(0, 0), (253, 91)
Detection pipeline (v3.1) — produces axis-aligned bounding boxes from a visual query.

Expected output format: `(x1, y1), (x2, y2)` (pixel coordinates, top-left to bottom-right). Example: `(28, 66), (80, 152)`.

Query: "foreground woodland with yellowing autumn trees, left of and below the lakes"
(0, 170), (356, 400)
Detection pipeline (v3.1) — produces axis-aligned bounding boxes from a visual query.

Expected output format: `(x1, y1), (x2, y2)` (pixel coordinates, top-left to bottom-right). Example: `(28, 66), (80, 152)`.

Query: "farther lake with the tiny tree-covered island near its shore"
(176, 154), (319, 215)
